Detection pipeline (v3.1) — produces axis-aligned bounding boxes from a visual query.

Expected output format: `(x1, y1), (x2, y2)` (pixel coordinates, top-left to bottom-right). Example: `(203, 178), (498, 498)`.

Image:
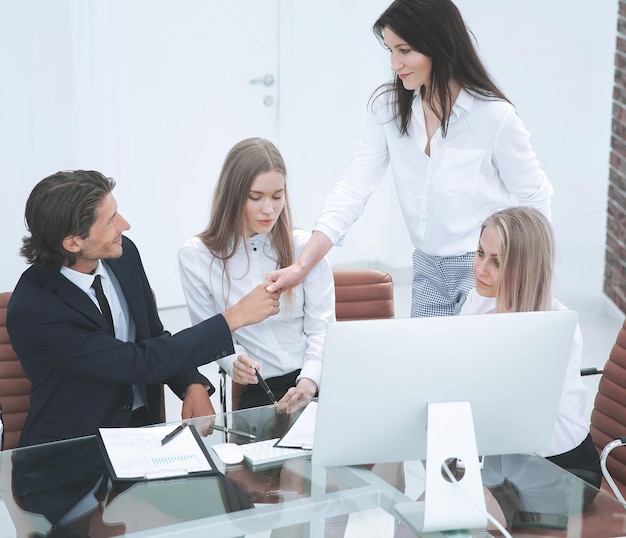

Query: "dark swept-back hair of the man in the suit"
(20, 170), (115, 271)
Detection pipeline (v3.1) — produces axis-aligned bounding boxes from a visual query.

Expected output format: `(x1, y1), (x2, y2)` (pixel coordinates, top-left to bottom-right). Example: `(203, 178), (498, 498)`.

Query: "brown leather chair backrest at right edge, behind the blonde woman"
(590, 321), (626, 495)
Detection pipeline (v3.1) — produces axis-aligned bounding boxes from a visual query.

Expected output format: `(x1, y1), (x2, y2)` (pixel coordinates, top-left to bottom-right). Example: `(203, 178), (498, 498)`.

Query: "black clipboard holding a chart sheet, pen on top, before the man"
(96, 424), (220, 482)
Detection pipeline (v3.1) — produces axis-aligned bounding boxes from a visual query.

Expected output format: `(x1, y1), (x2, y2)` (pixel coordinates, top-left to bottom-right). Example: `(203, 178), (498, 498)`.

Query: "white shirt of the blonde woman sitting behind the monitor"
(461, 288), (589, 457)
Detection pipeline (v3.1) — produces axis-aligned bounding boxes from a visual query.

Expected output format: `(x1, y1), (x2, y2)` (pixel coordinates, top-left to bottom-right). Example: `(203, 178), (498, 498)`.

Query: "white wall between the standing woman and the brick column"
(450, 0), (618, 294)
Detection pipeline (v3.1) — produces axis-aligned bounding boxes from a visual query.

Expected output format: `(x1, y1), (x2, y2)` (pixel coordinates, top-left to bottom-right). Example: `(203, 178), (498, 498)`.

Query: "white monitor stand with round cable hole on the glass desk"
(395, 402), (487, 532)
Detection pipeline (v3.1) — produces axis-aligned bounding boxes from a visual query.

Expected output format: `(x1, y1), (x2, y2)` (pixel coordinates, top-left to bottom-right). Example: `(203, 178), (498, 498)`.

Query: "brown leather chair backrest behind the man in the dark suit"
(0, 292), (30, 450)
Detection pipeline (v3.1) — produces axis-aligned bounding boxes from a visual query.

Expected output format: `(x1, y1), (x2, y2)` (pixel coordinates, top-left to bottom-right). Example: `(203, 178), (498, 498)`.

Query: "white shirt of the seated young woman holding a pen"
(178, 230), (335, 387)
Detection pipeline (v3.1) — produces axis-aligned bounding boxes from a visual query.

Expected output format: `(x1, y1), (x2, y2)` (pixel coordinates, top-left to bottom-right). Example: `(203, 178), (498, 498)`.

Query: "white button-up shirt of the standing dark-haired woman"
(314, 90), (552, 256)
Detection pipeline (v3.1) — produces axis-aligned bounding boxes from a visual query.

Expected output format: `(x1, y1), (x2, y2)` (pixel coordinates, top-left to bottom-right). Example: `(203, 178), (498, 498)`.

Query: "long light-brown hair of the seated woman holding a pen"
(198, 138), (294, 286)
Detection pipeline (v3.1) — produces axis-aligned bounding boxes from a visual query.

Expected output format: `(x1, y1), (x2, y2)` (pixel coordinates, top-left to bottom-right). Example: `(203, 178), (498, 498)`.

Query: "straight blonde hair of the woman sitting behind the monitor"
(481, 207), (555, 312)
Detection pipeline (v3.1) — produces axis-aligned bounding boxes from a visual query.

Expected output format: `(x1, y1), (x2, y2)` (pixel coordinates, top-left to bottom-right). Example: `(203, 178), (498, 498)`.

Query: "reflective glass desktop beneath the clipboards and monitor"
(0, 400), (626, 538)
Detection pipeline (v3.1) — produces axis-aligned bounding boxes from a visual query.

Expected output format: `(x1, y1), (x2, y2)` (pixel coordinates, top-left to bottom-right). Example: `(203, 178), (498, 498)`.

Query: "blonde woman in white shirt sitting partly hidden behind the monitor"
(461, 207), (602, 487)
